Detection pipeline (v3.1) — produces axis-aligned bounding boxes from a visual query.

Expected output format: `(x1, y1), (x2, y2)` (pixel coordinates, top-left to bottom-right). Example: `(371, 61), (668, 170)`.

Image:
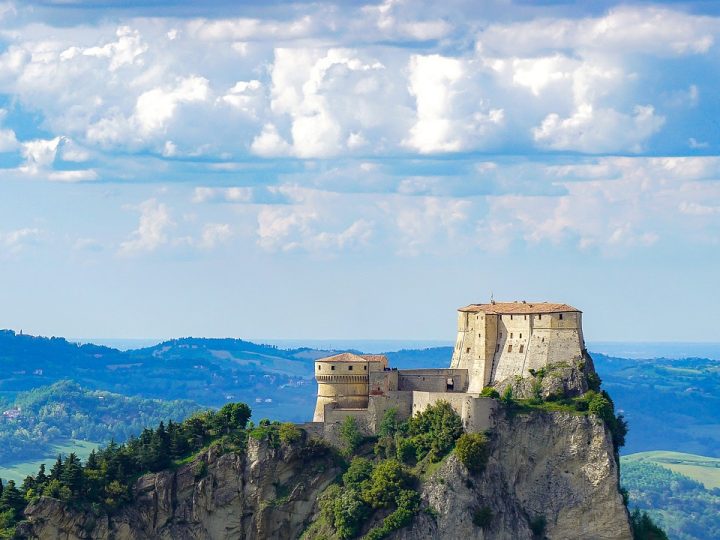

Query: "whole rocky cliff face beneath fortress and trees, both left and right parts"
(22, 411), (632, 540)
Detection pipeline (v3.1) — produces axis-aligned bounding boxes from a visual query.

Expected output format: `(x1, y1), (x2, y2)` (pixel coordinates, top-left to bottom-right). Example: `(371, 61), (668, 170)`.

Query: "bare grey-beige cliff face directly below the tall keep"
(397, 412), (632, 540)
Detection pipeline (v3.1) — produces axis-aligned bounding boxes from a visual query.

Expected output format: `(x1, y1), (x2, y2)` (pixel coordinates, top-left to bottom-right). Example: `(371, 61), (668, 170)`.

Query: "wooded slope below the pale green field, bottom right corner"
(620, 461), (720, 540)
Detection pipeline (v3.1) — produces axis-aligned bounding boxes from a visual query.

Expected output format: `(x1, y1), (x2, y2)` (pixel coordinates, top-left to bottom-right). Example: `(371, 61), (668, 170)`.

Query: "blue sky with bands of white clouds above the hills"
(0, 0), (720, 341)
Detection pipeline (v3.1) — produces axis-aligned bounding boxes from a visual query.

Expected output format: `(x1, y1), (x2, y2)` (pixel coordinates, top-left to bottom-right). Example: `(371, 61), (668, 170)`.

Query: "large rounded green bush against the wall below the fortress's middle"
(398, 401), (463, 462)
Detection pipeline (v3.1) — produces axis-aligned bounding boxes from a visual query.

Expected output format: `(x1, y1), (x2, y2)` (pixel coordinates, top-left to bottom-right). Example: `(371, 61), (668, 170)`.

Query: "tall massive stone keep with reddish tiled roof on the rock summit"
(450, 302), (585, 393)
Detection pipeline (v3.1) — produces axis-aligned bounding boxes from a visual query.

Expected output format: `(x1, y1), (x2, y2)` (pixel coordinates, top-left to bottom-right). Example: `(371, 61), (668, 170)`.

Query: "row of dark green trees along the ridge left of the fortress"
(0, 403), (256, 537)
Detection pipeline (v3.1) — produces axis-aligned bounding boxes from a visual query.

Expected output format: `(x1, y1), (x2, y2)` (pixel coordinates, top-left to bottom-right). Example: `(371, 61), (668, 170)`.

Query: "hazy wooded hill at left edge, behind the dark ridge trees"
(0, 381), (202, 463)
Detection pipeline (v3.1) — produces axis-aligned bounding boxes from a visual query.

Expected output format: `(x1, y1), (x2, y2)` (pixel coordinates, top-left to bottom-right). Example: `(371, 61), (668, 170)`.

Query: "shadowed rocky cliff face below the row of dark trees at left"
(19, 439), (340, 540)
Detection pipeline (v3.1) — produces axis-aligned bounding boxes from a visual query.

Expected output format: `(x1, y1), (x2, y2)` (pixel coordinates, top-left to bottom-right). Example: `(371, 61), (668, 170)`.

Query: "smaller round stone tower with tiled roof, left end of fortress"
(313, 353), (388, 422)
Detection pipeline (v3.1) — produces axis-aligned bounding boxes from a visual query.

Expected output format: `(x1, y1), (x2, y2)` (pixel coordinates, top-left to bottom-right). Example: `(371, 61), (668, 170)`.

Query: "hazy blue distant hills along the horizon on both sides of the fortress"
(0, 331), (720, 457)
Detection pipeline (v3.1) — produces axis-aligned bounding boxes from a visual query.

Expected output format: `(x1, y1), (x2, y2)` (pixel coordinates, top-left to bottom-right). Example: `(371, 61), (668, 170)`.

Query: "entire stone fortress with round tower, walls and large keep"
(313, 302), (587, 438)
